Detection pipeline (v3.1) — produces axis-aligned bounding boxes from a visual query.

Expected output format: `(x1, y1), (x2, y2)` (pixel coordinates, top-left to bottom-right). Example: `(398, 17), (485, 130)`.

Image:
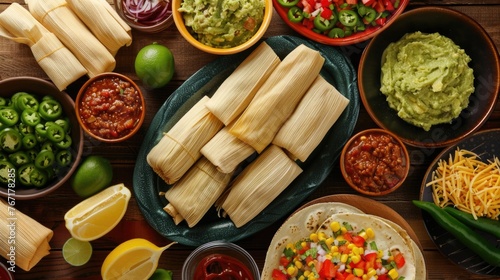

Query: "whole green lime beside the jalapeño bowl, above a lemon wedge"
(70, 155), (113, 198)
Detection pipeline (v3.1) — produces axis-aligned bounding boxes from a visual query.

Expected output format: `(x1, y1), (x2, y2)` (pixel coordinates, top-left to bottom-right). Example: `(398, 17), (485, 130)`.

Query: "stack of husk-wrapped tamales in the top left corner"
(0, 0), (132, 90)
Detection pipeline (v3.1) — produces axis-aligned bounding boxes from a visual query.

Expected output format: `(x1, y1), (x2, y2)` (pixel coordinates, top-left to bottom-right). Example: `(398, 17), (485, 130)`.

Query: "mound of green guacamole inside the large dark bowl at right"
(380, 32), (474, 131)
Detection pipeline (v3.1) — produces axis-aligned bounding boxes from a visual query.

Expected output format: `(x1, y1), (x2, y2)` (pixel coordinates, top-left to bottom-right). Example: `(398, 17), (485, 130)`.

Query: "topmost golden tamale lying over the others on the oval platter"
(229, 45), (325, 153)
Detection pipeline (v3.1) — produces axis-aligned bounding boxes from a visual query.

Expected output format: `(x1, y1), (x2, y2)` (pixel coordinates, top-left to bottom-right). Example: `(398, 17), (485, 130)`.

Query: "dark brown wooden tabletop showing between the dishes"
(0, 0), (500, 280)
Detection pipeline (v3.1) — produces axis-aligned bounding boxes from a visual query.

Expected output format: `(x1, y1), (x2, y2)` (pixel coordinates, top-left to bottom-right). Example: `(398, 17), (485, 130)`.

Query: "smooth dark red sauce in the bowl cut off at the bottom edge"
(194, 254), (253, 280)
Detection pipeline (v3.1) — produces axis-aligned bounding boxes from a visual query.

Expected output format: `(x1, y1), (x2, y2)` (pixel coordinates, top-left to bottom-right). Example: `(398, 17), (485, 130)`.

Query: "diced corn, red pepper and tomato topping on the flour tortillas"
(272, 221), (405, 280)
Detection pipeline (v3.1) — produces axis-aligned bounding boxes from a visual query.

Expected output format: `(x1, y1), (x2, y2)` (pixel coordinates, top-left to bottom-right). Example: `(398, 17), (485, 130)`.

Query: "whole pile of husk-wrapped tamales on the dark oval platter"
(147, 43), (349, 227)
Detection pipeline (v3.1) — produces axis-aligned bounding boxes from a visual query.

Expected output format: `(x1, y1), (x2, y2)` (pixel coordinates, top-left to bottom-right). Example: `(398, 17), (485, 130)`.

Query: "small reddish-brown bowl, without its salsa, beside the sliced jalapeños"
(75, 72), (146, 143)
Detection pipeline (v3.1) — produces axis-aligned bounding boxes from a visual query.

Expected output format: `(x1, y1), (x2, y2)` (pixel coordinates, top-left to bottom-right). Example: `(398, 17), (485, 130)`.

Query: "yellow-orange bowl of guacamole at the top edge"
(172, 0), (272, 54)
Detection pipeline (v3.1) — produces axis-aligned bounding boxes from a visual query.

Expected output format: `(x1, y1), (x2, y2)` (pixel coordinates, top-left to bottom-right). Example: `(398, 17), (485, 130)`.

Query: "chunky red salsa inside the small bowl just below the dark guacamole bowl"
(344, 134), (407, 193)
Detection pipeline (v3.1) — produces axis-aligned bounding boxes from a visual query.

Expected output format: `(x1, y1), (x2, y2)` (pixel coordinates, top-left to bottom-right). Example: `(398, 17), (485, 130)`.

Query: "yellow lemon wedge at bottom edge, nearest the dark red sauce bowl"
(101, 238), (176, 280)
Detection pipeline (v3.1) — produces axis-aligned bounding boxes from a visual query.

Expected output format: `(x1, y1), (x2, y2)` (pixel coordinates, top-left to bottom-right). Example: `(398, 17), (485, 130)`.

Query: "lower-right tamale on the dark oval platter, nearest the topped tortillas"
(216, 144), (302, 228)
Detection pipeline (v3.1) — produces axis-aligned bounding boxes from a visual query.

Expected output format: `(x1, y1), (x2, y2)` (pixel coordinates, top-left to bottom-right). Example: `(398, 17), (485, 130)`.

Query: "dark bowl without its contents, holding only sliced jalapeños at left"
(0, 77), (83, 200)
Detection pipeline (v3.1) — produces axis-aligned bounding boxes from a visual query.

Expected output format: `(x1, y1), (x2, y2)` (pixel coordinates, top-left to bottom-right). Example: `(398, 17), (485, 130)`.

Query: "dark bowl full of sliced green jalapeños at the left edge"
(0, 77), (83, 200)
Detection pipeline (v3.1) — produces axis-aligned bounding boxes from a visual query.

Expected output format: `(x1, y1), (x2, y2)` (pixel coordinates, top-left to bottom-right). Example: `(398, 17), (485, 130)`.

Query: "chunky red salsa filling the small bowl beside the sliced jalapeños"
(79, 77), (143, 139)
